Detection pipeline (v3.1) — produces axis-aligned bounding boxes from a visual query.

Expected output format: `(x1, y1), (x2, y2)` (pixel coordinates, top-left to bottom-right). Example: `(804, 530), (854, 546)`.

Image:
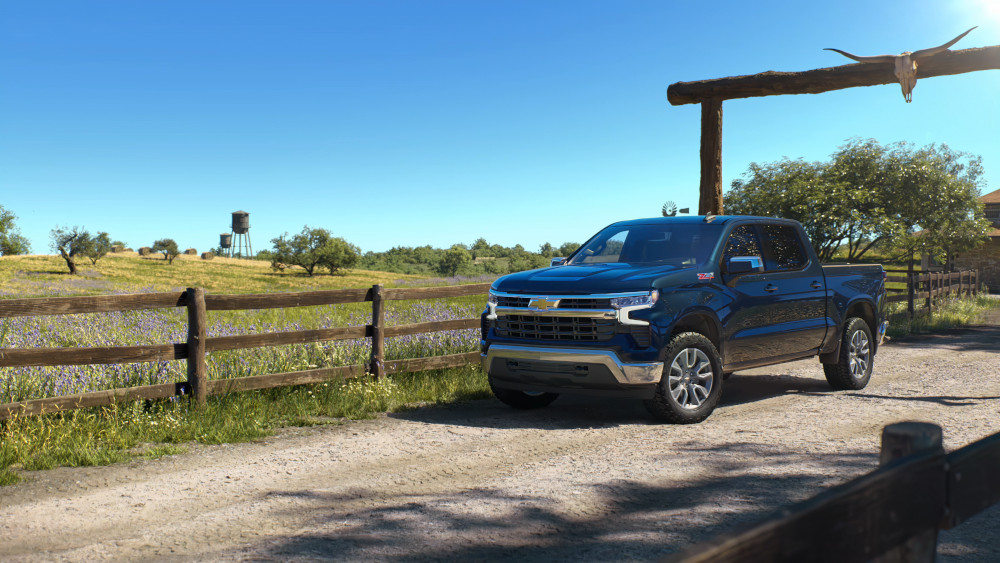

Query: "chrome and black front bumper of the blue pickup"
(480, 344), (663, 387)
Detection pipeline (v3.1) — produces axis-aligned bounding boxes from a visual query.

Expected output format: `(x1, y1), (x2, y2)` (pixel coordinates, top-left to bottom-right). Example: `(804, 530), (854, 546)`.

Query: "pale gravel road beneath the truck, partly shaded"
(0, 326), (1000, 561)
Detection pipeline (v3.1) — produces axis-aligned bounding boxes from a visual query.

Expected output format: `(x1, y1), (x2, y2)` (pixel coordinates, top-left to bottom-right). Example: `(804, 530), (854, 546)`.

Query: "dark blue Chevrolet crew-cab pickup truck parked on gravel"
(481, 215), (888, 423)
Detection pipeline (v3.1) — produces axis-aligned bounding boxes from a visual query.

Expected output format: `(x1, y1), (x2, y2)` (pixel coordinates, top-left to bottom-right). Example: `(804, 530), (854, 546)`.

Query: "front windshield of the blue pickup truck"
(567, 223), (721, 266)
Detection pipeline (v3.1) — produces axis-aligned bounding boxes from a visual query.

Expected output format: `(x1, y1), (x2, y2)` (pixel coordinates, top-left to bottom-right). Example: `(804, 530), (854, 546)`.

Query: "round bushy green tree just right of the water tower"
(271, 225), (361, 276)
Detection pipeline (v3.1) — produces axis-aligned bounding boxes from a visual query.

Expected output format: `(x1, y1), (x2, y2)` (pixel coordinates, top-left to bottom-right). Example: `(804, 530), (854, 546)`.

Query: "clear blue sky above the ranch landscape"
(0, 0), (1000, 253)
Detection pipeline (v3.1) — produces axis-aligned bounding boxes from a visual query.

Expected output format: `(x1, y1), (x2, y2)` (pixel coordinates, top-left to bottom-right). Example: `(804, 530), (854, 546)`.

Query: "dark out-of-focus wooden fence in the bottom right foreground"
(666, 422), (1000, 563)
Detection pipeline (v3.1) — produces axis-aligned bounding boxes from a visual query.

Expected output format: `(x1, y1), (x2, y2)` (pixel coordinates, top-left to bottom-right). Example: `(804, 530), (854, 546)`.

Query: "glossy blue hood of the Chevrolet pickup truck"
(493, 262), (693, 295)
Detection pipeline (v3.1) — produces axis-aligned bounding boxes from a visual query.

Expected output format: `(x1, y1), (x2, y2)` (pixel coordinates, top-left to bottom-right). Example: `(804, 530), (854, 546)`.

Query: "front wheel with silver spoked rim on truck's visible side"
(645, 332), (723, 424)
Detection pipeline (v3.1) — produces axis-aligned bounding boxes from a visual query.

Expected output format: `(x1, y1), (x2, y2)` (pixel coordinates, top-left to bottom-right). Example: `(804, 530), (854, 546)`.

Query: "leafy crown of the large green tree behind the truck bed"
(725, 139), (988, 262)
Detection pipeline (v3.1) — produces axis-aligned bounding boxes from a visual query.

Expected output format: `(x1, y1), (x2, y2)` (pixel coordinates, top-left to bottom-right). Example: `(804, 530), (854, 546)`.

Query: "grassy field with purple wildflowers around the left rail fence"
(0, 254), (489, 484)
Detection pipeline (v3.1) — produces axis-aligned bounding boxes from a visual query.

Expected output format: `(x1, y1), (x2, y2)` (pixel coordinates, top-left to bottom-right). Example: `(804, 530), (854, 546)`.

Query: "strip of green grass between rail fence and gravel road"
(0, 366), (490, 486)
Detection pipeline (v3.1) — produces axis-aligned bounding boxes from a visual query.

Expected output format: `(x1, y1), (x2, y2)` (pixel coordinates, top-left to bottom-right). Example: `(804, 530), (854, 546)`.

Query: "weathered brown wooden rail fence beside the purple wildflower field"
(0, 283), (490, 420)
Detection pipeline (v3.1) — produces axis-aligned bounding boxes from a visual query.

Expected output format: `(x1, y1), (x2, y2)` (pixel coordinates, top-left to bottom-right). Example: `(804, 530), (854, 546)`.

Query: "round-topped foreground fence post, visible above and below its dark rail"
(875, 422), (944, 563)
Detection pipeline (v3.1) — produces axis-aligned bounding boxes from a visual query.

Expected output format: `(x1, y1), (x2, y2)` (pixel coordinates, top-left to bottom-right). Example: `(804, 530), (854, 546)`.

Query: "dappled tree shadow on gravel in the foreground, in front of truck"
(250, 442), (877, 561)
